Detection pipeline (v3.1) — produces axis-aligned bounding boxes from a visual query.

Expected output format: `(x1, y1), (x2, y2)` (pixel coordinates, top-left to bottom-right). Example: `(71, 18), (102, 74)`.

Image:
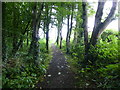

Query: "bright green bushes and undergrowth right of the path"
(65, 31), (120, 88)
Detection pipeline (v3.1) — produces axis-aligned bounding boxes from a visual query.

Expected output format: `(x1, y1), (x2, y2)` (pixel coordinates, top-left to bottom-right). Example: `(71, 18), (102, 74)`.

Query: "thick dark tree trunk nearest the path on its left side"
(29, 2), (44, 64)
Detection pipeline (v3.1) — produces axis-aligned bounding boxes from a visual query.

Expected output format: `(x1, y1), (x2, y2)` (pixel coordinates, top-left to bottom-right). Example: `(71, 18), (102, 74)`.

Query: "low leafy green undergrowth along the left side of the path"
(2, 40), (51, 88)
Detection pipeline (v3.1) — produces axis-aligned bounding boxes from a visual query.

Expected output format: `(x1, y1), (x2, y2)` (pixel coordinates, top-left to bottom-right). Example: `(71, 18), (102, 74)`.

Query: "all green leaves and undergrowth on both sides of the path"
(0, 2), (120, 88)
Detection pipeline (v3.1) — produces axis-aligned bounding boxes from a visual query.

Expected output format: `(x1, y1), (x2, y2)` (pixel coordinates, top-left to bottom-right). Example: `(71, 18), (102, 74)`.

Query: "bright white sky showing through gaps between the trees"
(39, 1), (118, 42)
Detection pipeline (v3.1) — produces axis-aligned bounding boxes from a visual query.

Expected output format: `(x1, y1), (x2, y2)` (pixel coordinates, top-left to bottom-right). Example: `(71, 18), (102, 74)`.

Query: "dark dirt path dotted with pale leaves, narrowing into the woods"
(37, 44), (76, 88)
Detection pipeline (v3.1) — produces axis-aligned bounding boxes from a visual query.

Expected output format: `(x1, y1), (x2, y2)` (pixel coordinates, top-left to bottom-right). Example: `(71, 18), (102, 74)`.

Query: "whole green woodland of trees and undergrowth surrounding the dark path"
(2, 1), (120, 88)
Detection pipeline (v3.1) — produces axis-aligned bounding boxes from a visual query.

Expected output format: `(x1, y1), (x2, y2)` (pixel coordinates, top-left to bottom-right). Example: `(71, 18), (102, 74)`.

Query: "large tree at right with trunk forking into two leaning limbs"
(86, 0), (117, 62)
